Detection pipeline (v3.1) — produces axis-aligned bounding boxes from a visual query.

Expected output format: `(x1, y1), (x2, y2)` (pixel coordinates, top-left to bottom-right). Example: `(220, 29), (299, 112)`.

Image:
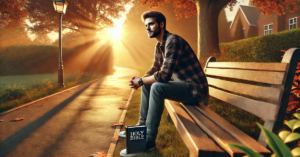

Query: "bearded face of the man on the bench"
(145, 17), (161, 38)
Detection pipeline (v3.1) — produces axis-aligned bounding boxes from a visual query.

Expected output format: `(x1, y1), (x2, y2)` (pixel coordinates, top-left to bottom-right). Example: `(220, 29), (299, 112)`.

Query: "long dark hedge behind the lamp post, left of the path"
(0, 45), (113, 75)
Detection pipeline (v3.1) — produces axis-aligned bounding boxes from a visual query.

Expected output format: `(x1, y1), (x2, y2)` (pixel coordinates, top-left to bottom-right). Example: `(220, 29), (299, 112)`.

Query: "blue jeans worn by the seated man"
(139, 81), (199, 140)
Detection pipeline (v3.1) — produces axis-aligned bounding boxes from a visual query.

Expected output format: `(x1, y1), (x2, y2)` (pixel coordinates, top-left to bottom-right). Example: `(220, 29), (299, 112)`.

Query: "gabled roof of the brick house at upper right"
(230, 5), (260, 28)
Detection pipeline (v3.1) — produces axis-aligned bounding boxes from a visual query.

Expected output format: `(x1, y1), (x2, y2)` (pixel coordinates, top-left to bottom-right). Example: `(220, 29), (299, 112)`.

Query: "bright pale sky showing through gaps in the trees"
(26, 0), (249, 41)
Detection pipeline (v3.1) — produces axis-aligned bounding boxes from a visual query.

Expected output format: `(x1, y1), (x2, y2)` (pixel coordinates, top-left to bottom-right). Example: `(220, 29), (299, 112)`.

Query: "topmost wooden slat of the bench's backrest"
(207, 62), (288, 71)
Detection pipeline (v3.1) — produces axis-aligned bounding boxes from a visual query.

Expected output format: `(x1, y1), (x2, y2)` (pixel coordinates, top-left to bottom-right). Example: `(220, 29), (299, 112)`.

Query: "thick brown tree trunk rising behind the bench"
(195, 0), (230, 64)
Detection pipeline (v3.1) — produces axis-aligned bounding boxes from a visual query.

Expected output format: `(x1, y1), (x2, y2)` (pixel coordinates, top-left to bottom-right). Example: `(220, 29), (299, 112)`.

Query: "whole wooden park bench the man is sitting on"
(166, 48), (300, 157)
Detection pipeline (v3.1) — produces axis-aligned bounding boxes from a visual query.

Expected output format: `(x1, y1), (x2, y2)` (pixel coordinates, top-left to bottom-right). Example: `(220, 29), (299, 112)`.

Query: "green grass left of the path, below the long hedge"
(0, 73), (104, 112)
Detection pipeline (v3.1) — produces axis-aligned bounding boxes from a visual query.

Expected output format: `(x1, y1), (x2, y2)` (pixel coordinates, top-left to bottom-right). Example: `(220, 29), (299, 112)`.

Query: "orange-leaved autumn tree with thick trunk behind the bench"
(139, 0), (297, 62)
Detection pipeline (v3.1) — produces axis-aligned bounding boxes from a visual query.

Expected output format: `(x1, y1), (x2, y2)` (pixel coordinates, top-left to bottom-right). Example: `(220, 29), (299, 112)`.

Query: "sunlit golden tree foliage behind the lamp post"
(26, 0), (130, 47)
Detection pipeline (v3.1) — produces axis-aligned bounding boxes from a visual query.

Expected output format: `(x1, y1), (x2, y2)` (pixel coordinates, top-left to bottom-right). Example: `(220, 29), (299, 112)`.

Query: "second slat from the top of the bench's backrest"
(205, 68), (285, 85)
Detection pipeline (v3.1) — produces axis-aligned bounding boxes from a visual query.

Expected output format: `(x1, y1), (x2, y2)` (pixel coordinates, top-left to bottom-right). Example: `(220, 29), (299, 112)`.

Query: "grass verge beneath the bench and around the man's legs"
(114, 63), (262, 157)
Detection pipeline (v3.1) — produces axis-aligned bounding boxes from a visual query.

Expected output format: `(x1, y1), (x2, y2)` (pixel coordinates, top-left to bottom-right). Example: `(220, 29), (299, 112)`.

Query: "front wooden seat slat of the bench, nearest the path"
(165, 100), (227, 156)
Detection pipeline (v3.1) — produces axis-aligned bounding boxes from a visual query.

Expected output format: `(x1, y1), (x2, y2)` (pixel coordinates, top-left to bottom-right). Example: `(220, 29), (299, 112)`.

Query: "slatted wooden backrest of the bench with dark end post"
(204, 48), (300, 146)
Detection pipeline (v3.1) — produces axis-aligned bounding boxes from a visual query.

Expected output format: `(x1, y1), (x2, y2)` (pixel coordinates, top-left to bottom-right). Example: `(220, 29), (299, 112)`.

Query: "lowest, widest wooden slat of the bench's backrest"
(209, 87), (279, 120)
